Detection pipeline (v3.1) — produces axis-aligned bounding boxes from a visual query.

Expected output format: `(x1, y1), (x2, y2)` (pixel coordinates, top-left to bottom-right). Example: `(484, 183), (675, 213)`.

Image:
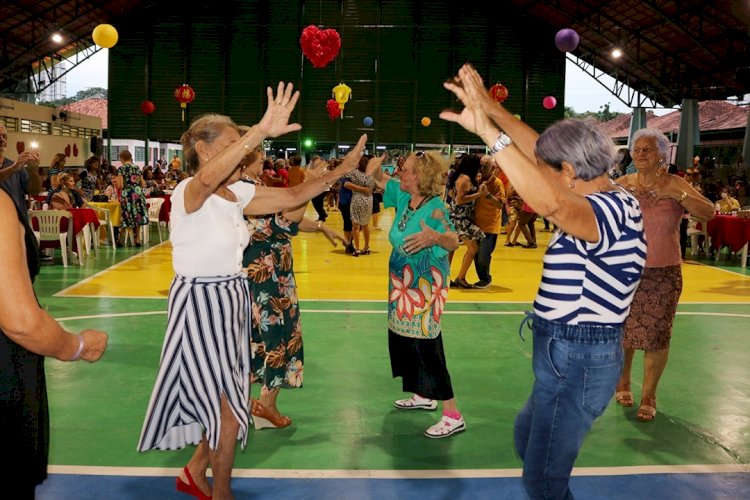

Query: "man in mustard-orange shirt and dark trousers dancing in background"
(474, 155), (505, 288)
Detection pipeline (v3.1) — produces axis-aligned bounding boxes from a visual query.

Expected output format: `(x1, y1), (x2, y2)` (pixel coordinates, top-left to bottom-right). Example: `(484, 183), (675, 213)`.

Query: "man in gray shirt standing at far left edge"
(0, 124), (42, 220)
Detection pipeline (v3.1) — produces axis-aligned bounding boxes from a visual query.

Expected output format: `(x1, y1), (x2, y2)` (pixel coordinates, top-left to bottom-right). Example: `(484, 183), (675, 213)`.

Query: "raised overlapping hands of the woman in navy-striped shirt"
(440, 63), (496, 140)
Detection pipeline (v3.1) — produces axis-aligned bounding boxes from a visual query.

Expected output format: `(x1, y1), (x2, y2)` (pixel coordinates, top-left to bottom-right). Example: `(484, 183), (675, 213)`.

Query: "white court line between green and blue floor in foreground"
(48, 464), (750, 479)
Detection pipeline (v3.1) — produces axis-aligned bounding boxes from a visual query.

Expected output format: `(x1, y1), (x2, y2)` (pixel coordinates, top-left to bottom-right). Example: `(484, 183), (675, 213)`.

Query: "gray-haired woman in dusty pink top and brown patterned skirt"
(615, 128), (714, 422)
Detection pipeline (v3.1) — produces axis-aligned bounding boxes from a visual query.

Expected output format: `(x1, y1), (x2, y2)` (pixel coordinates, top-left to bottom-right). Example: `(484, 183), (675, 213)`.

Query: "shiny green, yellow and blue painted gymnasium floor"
(30, 211), (750, 500)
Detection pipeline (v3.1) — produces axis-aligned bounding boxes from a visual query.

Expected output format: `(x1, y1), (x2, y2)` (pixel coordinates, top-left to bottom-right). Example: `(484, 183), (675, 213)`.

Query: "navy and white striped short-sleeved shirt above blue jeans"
(534, 190), (646, 326)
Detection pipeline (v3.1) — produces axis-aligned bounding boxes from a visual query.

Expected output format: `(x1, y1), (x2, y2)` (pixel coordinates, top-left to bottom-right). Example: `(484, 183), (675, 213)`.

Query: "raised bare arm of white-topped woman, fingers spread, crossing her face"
(185, 82), (302, 213)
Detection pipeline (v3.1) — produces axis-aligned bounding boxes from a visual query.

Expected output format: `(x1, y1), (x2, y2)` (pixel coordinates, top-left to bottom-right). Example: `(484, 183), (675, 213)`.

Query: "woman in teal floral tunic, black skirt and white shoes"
(367, 151), (466, 438)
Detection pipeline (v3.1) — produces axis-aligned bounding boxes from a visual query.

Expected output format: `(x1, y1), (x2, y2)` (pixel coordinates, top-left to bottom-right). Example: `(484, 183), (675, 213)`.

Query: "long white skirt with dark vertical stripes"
(138, 274), (251, 451)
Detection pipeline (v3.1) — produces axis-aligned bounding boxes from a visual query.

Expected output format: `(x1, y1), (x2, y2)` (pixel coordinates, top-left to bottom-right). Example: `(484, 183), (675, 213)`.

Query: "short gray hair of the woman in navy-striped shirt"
(534, 119), (615, 181)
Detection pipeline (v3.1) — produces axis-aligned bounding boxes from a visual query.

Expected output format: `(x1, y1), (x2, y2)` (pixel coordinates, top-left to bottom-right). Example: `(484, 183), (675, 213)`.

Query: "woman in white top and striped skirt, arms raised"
(138, 83), (367, 500)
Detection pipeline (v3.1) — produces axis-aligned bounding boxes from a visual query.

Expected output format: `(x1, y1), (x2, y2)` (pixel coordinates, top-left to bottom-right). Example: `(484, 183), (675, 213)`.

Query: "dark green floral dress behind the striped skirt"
(243, 180), (304, 389)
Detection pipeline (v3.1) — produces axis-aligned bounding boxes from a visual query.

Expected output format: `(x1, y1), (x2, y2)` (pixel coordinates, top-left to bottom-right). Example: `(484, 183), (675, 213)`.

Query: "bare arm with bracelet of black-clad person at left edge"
(0, 193), (107, 361)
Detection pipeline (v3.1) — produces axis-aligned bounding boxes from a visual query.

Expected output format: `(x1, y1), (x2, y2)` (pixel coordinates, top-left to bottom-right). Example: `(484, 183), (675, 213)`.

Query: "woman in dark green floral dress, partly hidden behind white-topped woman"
(243, 143), (344, 429)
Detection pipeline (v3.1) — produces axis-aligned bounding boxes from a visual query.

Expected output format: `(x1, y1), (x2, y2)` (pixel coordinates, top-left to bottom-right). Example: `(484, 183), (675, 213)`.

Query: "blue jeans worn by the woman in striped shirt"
(514, 313), (623, 500)
